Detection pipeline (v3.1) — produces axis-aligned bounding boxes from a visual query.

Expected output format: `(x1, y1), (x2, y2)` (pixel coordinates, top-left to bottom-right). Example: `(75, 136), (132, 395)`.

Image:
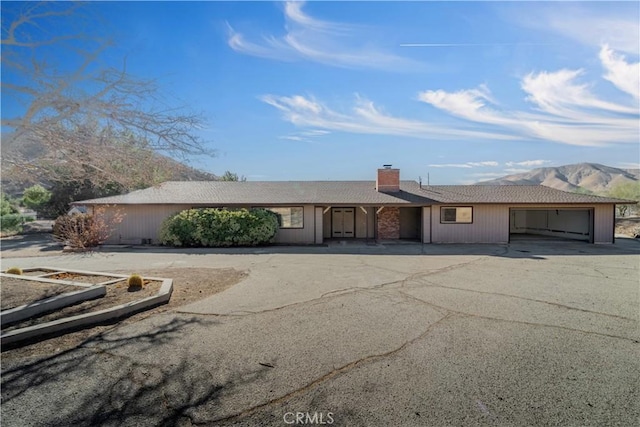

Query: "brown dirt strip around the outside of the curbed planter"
(2, 268), (247, 359)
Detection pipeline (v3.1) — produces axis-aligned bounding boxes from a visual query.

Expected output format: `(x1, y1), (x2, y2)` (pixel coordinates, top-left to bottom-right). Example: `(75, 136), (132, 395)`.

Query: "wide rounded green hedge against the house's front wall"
(160, 208), (278, 247)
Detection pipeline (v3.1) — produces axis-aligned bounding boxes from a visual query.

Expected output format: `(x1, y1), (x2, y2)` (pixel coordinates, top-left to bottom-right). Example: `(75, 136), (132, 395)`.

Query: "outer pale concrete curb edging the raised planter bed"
(0, 267), (173, 345)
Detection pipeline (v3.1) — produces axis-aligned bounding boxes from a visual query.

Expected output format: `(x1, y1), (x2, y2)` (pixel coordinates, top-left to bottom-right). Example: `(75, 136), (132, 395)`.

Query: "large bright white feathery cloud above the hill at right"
(418, 46), (640, 146)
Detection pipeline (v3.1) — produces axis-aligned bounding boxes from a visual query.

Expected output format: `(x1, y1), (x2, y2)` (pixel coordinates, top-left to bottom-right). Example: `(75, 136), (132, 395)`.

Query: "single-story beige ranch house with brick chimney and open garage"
(74, 166), (635, 244)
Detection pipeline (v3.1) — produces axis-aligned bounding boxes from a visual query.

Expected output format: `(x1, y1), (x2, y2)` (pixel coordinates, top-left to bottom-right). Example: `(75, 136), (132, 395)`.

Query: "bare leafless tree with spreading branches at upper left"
(2, 2), (211, 188)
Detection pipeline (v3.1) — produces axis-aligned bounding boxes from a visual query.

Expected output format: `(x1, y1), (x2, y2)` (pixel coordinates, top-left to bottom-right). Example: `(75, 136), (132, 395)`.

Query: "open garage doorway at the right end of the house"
(509, 208), (593, 243)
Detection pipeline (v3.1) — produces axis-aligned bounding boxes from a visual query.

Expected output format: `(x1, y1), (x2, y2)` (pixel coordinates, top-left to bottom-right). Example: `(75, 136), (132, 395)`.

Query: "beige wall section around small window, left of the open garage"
(431, 204), (509, 243)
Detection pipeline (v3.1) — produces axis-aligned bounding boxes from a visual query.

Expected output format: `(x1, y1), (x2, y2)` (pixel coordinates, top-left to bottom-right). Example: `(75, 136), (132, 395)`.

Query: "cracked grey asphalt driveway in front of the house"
(1, 239), (640, 426)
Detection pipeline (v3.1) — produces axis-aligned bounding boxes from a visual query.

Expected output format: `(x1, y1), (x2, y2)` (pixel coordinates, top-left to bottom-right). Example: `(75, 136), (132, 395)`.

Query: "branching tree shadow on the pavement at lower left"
(1, 317), (265, 426)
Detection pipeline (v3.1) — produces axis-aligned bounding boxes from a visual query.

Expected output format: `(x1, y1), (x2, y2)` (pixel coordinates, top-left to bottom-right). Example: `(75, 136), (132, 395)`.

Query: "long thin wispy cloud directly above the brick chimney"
(260, 95), (517, 140)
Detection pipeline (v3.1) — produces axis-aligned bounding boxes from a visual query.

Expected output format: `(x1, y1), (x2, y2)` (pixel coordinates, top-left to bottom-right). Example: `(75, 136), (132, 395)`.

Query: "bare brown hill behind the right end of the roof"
(478, 163), (640, 194)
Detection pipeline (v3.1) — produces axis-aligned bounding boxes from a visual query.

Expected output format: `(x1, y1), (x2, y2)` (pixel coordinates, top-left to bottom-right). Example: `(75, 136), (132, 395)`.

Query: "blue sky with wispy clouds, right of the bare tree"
(3, 2), (640, 184)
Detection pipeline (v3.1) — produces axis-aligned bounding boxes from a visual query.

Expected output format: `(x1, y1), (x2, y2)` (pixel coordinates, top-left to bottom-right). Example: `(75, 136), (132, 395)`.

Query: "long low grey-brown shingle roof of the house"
(74, 181), (635, 206)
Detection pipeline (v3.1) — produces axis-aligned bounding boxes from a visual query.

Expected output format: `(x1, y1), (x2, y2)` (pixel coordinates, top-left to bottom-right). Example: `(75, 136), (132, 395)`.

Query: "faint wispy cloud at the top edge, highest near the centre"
(227, 2), (424, 71)
